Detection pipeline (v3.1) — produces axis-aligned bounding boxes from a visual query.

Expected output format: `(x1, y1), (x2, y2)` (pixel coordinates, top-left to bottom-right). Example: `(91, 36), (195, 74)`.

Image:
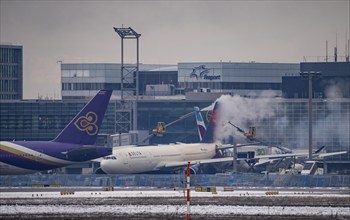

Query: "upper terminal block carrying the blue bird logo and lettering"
(178, 62), (300, 96)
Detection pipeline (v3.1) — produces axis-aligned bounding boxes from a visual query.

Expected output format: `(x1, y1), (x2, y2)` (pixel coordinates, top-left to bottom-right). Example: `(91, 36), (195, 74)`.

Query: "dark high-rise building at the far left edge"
(0, 45), (23, 100)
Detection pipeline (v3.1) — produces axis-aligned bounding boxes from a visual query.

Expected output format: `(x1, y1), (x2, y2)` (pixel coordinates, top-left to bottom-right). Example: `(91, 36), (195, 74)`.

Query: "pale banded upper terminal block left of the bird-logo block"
(61, 63), (177, 99)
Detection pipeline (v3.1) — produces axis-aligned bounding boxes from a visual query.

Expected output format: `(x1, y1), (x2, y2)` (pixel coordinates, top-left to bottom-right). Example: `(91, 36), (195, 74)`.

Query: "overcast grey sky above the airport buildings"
(0, 0), (350, 99)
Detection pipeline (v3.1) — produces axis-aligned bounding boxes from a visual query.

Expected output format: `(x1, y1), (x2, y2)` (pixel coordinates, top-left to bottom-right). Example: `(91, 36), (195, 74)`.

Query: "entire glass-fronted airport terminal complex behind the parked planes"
(0, 58), (350, 172)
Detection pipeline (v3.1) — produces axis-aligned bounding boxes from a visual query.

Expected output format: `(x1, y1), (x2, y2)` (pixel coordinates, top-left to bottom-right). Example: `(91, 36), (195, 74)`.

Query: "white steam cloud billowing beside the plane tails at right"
(211, 83), (350, 151)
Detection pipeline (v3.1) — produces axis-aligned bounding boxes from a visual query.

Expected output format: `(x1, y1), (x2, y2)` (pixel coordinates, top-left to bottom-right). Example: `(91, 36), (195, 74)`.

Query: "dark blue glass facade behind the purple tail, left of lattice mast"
(0, 100), (115, 141)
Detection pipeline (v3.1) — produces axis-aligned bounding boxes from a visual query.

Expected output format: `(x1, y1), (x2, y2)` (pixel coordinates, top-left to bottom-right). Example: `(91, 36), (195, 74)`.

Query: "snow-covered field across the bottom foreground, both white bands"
(0, 188), (350, 219)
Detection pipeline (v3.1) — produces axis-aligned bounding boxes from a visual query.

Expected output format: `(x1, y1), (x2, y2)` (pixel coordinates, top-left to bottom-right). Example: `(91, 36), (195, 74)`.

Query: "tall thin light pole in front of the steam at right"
(300, 71), (321, 160)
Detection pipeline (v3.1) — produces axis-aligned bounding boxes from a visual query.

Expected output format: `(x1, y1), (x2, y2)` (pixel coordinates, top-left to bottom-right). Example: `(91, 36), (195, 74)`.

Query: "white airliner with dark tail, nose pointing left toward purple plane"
(101, 103), (254, 174)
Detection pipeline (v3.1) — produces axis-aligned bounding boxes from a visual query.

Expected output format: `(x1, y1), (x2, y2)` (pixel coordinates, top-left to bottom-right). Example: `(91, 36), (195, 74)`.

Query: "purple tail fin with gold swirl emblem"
(53, 90), (112, 145)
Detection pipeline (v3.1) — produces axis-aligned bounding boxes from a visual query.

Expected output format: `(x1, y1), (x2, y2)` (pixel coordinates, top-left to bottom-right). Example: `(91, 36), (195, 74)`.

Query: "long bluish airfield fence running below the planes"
(0, 174), (350, 188)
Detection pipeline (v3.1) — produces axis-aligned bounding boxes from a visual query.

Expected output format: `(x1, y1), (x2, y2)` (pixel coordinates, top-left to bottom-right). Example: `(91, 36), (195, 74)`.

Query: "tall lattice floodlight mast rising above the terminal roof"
(114, 27), (141, 132)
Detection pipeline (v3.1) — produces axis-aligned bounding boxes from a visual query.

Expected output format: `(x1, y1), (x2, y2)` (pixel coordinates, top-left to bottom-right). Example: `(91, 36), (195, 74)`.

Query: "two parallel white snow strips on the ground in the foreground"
(0, 187), (350, 218)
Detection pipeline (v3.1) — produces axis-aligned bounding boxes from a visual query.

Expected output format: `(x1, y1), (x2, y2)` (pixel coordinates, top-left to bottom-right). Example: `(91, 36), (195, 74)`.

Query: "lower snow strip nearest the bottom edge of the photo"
(0, 205), (350, 217)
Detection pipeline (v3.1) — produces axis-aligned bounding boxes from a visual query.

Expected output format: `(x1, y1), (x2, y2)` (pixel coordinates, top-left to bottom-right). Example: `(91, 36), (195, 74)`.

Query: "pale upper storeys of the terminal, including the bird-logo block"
(61, 62), (300, 99)
